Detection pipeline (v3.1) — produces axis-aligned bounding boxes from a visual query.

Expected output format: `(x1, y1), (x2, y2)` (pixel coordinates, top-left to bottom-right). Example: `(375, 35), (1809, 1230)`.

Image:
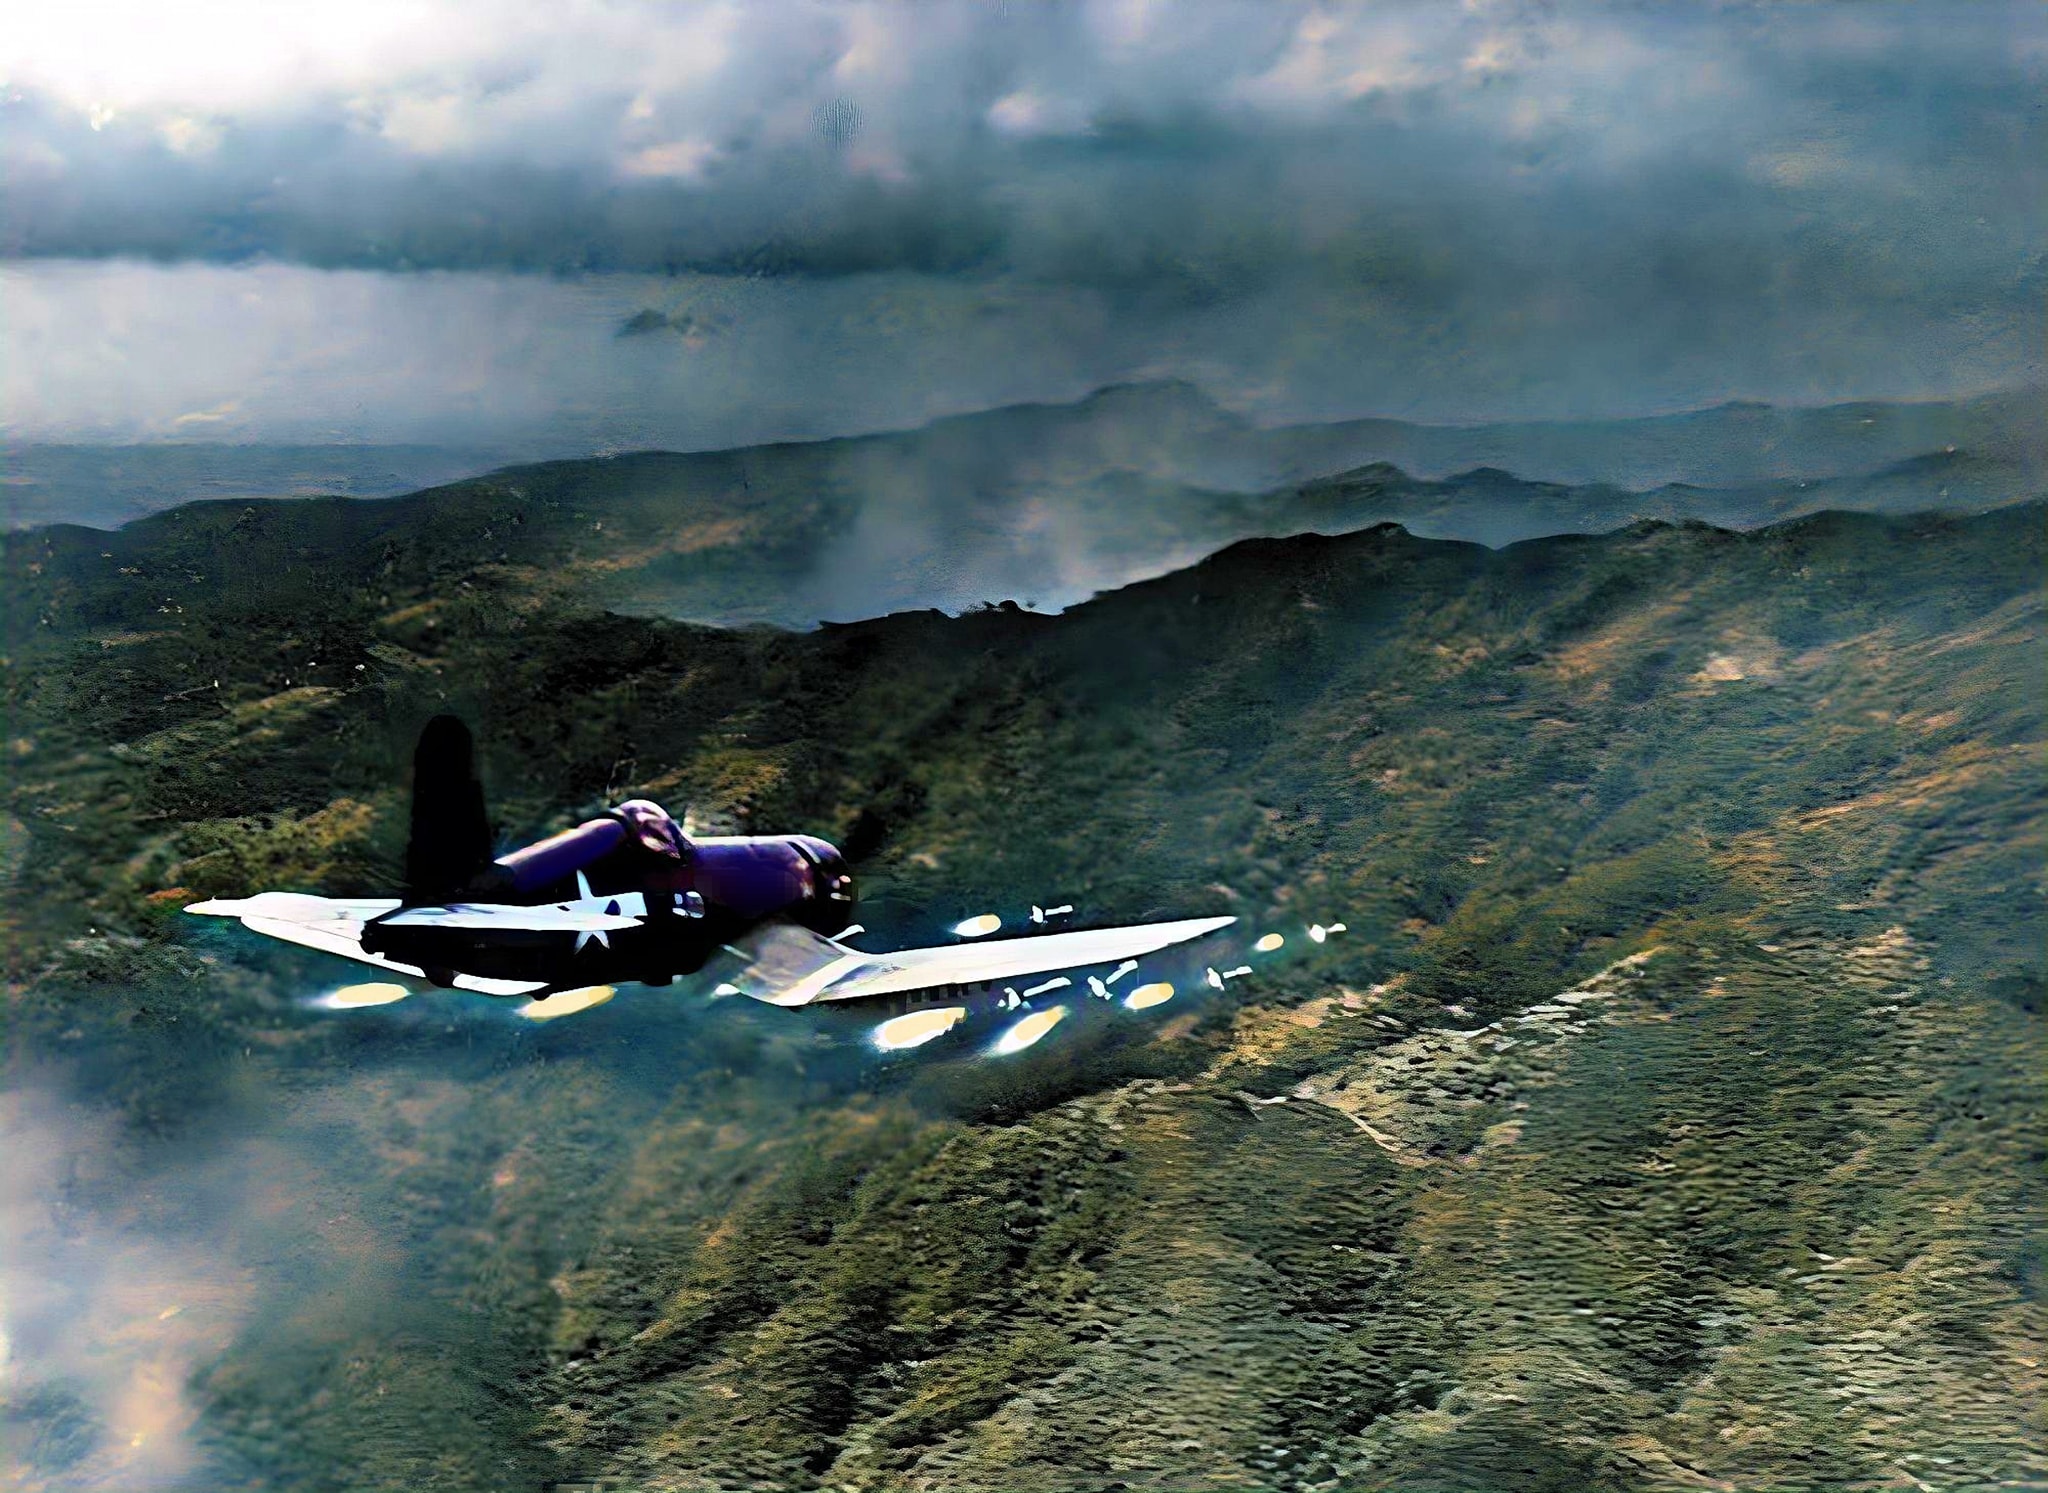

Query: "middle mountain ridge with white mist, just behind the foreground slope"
(0, 442), (2042, 637)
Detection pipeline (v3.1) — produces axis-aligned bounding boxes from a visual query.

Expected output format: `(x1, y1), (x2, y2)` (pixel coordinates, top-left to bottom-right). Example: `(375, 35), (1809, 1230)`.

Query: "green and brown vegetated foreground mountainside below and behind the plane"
(0, 495), (2048, 1489)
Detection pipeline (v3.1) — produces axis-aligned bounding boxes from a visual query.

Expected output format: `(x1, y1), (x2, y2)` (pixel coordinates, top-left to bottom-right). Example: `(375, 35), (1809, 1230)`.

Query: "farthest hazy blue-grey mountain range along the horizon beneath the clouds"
(0, 381), (2048, 536)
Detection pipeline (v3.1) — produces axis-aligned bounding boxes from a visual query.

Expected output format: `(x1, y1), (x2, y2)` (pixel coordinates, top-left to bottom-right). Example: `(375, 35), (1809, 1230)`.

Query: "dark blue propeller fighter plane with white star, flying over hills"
(186, 715), (1235, 1008)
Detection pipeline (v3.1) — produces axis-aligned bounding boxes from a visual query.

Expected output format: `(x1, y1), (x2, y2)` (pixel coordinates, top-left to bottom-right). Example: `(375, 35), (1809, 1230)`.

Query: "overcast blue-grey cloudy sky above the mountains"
(0, 0), (2048, 449)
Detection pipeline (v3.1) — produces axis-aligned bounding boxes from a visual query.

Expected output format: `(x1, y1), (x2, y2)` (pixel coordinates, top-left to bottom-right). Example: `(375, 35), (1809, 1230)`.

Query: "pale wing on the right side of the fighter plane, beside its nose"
(735, 918), (1237, 1006)
